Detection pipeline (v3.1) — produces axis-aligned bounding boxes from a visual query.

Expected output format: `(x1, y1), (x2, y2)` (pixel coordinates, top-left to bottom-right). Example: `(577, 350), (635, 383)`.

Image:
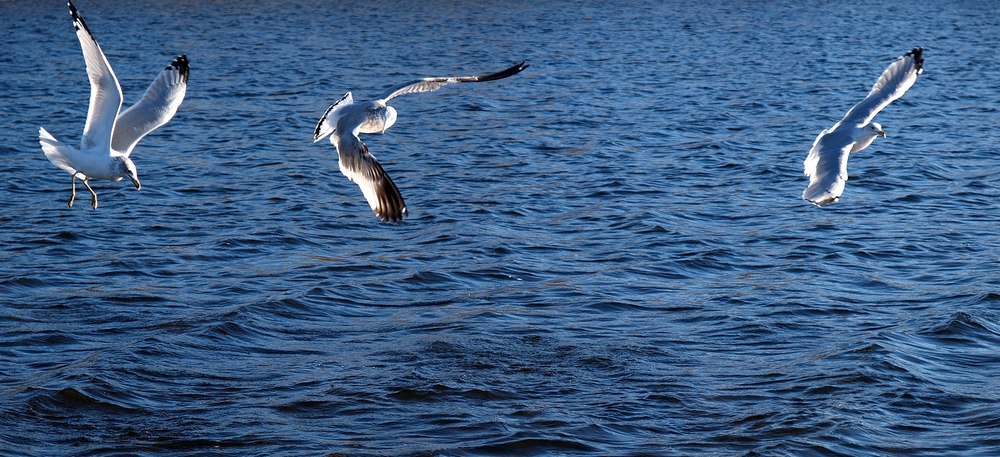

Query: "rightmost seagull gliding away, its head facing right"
(802, 48), (924, 206)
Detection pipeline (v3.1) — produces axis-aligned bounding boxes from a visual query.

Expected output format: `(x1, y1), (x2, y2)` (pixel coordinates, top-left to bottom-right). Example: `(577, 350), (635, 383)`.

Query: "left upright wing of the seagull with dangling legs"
(67, 2), (122, 151)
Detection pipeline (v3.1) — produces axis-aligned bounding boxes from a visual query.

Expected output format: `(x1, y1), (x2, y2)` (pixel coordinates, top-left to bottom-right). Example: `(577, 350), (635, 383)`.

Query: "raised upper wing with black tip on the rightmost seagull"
(840, 48), (924, 125)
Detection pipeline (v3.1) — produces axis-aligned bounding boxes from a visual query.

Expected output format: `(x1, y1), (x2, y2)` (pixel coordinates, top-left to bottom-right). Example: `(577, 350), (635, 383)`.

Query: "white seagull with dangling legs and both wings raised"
(38, 1), (190, 209)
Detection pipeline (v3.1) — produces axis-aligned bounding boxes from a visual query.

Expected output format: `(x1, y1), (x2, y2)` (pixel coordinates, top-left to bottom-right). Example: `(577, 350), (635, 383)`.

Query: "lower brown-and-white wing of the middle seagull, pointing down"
(331, 133), (406, 223)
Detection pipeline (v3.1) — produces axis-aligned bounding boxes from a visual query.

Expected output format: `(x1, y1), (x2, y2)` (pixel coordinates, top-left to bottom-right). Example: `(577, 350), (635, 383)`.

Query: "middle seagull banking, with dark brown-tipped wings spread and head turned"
(313, 62), (528, 223)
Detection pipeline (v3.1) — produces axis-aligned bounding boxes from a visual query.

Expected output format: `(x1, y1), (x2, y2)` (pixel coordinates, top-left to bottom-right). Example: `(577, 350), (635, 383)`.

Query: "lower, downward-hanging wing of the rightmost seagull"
(802, 129), (854, 206)
